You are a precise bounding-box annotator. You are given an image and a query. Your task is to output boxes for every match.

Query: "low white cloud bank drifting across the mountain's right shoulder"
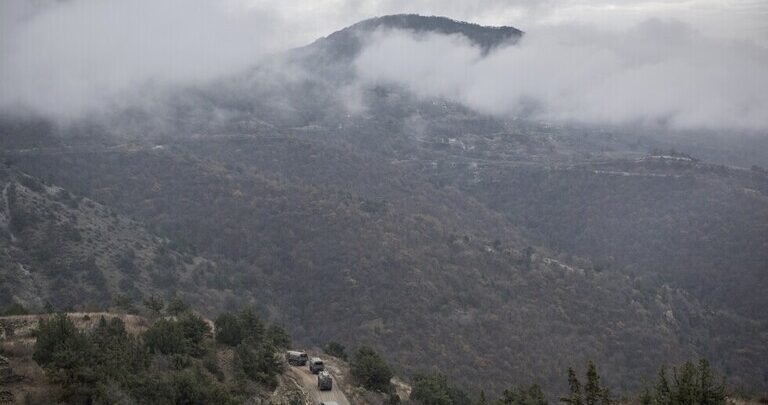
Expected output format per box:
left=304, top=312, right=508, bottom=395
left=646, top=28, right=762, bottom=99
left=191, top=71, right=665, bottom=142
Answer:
left=355, top=20, right=768, bottom=130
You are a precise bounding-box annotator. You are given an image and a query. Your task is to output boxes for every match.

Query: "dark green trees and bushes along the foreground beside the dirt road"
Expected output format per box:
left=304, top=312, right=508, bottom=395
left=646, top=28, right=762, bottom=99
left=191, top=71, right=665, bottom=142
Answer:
left=28, top=301, right=727, bottom=405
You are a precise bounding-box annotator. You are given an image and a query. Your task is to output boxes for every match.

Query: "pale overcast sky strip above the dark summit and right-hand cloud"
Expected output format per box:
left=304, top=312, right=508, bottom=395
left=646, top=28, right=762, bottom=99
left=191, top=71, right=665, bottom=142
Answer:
left=244, top=0, right=768, bottom=45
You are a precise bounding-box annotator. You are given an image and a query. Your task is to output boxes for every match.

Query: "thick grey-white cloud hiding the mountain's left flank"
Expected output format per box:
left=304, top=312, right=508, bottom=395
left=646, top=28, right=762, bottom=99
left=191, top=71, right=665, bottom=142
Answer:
left=0, top=0, right=290, bottom=119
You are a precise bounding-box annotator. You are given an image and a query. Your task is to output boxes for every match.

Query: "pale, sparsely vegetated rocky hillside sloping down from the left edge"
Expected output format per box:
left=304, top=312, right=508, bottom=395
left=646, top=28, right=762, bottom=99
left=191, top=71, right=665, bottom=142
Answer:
left=0, top=164, right=222, bottom=308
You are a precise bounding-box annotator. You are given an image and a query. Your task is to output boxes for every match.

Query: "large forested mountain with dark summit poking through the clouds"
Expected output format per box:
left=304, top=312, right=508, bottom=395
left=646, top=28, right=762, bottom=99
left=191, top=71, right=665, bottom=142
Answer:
left=0, top=16, right=768, bottom=397
